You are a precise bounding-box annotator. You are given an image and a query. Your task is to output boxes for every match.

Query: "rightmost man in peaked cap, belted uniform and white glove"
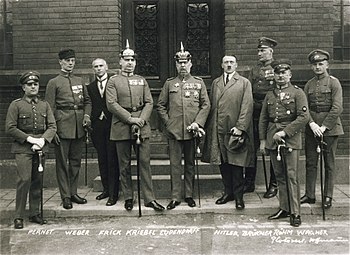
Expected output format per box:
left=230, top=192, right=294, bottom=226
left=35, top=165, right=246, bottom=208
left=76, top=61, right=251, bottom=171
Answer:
left=300, top=49, right=344, bottom=209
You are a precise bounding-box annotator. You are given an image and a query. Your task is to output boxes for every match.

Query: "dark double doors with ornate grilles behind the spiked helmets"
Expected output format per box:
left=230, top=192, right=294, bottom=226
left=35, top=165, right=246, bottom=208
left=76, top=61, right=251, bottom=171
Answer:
left=122, top=0, right=224, bottom=90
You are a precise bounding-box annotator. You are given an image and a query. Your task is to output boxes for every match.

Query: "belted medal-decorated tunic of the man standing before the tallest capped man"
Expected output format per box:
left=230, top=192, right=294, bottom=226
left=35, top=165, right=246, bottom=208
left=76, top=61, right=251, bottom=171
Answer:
left=259, top=83, right=310, bottom=150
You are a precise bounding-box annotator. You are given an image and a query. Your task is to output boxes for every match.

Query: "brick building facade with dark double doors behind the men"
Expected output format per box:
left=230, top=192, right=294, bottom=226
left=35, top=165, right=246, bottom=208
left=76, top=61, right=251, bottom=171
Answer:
left=0, top=0, right=350, bottom=185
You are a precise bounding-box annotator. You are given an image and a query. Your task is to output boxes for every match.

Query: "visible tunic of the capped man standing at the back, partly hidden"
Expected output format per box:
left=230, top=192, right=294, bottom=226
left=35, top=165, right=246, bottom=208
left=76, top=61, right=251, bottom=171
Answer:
left=248, top=59, right=276, bottom=118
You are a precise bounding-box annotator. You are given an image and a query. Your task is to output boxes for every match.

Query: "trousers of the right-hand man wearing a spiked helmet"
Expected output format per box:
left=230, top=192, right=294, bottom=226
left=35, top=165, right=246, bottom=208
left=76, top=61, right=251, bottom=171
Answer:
left=169, top=139, right=195, bottom=201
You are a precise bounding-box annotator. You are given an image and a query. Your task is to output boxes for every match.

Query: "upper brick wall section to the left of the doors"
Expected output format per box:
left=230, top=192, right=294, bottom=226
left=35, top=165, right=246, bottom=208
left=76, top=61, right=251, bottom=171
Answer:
left=13, top=0, right=121, bottom=70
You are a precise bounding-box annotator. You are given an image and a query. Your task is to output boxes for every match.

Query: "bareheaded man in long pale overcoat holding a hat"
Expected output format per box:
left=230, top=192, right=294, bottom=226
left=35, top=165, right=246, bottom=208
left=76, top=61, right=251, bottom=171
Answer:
left=202, top=56, right=254, bottom=210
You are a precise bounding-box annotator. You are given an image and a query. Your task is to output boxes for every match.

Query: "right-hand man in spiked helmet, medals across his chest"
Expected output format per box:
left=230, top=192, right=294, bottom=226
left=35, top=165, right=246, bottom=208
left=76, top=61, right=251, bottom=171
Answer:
left=157, top=43, right=210, bottom=210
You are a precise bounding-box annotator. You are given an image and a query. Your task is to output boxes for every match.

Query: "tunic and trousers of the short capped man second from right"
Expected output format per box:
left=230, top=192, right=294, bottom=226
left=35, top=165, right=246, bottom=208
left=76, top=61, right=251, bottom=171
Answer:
left=259, top=83, right=309, bottom=215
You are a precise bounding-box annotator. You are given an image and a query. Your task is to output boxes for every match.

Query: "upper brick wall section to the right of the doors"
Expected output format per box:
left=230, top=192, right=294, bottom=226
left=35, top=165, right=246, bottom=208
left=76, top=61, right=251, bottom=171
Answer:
left=225, top=0, right=333, bottom=65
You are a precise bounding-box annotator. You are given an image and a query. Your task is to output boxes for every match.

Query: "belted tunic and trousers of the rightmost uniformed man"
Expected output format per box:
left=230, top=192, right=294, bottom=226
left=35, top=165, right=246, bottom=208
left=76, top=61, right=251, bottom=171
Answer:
left=304, top=74, right=344, bottom=198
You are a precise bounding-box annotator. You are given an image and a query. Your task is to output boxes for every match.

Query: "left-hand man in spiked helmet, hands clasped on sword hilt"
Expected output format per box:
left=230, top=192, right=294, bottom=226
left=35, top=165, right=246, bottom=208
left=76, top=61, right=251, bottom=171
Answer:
left=106, top=39, right=165, bottom=211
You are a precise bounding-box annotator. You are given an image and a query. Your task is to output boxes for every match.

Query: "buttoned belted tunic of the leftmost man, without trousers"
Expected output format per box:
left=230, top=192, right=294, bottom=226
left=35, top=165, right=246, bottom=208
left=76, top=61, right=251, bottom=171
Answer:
left=6, top=96, right=56, bottom=154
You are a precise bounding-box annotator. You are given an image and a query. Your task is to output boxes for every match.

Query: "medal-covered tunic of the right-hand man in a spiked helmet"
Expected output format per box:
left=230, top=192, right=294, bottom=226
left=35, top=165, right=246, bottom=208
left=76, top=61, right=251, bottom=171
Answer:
left=157, top=74, right=210, bottom=140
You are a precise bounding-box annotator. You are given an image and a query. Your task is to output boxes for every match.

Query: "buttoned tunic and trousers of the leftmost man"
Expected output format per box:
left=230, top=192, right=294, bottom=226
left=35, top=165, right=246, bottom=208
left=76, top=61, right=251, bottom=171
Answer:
left=6, top=96, right=56, bottom=219
